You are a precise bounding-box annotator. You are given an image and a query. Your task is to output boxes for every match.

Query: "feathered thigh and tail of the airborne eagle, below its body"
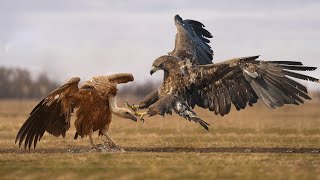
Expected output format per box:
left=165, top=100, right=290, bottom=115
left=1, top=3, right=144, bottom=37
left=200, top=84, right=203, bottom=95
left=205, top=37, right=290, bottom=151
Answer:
left=148, top=94, right=210, bottom=130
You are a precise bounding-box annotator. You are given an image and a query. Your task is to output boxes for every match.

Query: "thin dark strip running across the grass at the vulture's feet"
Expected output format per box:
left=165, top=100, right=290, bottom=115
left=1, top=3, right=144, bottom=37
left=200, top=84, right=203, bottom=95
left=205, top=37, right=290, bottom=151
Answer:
left=0, top=147, right=320, bottom=154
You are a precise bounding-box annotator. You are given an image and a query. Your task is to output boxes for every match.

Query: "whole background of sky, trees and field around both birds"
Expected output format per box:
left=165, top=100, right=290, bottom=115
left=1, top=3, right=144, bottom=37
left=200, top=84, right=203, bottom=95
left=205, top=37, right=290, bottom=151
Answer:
left=0, top=0, right=320, bottom=180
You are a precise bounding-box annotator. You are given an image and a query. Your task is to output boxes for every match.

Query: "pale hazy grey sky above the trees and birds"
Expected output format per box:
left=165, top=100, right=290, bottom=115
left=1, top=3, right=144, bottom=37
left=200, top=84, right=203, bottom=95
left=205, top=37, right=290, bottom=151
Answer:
left=0, top=0, right=320, bottom=88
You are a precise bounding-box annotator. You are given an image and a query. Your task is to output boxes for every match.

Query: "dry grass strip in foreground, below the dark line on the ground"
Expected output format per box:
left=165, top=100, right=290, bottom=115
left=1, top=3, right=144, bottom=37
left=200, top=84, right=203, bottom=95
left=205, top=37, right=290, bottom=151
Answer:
left=0, top=153, right=320, bottom=179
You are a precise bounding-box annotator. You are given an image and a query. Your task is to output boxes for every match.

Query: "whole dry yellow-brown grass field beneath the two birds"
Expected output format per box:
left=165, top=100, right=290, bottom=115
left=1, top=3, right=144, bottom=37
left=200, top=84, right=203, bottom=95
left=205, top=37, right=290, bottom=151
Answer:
left=0, top=100, right=320, bottom=179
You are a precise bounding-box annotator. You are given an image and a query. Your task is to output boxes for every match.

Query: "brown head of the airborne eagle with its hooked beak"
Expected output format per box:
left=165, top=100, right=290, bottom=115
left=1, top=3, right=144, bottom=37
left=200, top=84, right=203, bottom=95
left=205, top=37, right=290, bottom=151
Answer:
left=150, top=55, right=179, bottom=75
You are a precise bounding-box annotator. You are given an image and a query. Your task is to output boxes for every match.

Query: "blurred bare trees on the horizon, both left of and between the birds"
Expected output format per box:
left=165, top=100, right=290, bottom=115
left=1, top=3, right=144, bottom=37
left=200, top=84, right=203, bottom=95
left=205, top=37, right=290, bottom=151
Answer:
left=0, top=67, right=159, bottom=99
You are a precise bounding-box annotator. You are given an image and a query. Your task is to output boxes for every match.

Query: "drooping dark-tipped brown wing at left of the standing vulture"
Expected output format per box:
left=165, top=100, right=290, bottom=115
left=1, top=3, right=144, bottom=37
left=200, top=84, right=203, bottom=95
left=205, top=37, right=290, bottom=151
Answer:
left=16, top=77, right=80, bottom=149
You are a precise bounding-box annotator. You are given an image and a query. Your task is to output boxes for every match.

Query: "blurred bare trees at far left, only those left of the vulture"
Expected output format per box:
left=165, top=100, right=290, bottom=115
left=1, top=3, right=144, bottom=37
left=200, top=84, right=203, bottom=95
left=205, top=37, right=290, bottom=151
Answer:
left=0, top=67, right=59, bottom=99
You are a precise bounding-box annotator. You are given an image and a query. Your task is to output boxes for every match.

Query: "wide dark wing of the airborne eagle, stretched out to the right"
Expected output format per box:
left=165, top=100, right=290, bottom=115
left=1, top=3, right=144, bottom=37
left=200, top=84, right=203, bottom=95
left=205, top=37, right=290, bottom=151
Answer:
left=188, top=56, right=319, bottom=116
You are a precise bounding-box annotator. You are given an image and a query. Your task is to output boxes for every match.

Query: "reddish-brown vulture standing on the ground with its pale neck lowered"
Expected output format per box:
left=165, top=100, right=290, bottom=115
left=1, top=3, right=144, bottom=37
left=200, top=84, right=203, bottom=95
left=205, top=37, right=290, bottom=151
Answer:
left=15, top=73, right=137, bottom=151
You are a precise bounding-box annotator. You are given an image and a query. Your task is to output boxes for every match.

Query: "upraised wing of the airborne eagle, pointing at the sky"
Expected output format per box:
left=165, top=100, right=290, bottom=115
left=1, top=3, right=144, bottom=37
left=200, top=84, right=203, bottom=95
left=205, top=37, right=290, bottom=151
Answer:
left=169, top=15, right=213, bottom=64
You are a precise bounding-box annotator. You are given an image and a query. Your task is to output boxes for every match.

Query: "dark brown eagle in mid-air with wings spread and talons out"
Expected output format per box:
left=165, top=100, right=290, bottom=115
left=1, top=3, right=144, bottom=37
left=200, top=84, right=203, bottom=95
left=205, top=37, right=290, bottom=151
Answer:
left=127, top=15, right=319, bottom=130
